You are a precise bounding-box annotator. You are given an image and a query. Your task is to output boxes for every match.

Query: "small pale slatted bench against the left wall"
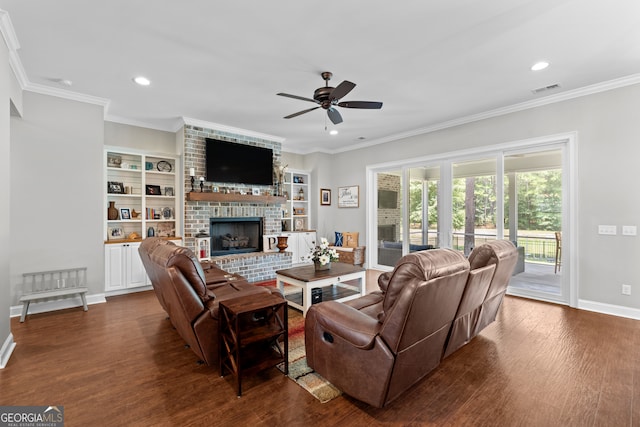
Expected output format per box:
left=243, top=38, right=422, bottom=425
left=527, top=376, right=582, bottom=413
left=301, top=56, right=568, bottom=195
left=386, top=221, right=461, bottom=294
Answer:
left=20, top=267, right=89, bottom=323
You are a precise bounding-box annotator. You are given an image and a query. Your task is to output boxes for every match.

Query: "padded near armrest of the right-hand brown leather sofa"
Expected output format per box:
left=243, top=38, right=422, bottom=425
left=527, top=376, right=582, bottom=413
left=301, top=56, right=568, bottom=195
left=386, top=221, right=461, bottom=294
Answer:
left=307, top=301, right=380, bottom=349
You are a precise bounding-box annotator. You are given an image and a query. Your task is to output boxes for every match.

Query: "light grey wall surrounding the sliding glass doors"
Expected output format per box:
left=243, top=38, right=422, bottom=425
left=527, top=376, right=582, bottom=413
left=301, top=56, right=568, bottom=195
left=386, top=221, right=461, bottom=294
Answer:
left=317, top=85, right=640, bottom=309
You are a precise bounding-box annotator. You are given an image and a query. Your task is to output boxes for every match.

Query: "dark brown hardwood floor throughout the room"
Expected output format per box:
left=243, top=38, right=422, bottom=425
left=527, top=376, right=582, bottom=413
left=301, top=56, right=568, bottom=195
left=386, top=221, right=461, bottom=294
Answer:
left=0, top=282, right=640, bottom=426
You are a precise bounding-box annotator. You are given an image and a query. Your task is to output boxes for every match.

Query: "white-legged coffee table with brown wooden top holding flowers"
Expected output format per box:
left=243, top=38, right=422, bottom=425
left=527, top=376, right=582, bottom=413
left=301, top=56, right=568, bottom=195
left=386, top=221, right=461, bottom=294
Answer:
left=276, top=262, right=366, bottom=316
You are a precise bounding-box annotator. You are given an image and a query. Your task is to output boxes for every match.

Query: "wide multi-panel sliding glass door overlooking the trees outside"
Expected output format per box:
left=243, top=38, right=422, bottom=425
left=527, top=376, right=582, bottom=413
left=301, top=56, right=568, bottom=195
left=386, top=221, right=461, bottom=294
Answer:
left=367, top=135, right=570, bottom=302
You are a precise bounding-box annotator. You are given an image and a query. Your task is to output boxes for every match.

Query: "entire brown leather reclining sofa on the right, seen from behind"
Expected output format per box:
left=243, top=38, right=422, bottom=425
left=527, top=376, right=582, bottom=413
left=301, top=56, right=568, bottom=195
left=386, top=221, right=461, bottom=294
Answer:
left=305, top=241, right=518, bottom=407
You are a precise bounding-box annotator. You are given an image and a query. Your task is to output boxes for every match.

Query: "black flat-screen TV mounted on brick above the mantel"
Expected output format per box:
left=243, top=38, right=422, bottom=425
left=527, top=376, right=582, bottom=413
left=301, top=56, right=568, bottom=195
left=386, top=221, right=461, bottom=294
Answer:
left=205, top=138, right=273, bottom=185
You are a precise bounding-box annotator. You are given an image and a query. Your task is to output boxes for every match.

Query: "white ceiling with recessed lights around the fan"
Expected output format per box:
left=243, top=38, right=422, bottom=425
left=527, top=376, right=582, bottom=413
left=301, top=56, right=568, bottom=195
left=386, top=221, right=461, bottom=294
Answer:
left=0, top=0, right=640, bottom=153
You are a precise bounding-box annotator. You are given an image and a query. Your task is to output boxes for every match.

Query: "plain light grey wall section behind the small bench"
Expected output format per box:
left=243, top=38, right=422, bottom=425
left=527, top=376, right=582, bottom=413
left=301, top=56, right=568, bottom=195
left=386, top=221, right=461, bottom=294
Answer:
left=9, top=92, right=104, bottom=305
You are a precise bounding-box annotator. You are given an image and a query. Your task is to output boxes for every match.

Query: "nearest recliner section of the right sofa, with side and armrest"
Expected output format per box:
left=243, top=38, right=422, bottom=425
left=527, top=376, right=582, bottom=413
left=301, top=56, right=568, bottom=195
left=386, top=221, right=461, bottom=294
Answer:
left=305, top=249, right=469, bottom=407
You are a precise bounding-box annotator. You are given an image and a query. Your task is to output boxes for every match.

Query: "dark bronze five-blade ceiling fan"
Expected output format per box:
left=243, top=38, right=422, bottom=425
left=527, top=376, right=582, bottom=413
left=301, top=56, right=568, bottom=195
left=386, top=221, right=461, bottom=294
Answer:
left=278, top=71, right=382, bottom=125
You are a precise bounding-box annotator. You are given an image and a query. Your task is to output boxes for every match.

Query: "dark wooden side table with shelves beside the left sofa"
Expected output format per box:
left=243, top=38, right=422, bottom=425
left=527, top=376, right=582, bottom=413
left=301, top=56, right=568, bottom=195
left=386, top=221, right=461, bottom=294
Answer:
left=218, top=293, right=289, bottom=397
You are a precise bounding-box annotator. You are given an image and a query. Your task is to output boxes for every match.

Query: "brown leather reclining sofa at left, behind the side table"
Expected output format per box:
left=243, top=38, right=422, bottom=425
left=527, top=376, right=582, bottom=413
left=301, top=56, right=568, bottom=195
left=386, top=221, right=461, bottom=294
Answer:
left=139, top=237, right=281, bottom=366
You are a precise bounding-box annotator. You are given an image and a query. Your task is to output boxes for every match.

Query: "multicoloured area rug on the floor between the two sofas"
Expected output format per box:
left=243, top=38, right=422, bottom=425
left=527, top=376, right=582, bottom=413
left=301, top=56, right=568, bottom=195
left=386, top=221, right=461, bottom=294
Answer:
left=254, top=280, right=342, bottom=403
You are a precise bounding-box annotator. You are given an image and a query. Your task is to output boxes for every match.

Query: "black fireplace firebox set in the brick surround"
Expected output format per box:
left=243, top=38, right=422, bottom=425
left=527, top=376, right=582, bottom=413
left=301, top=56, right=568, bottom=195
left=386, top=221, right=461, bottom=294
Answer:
left=209, top=217, right=263, bottom=256
